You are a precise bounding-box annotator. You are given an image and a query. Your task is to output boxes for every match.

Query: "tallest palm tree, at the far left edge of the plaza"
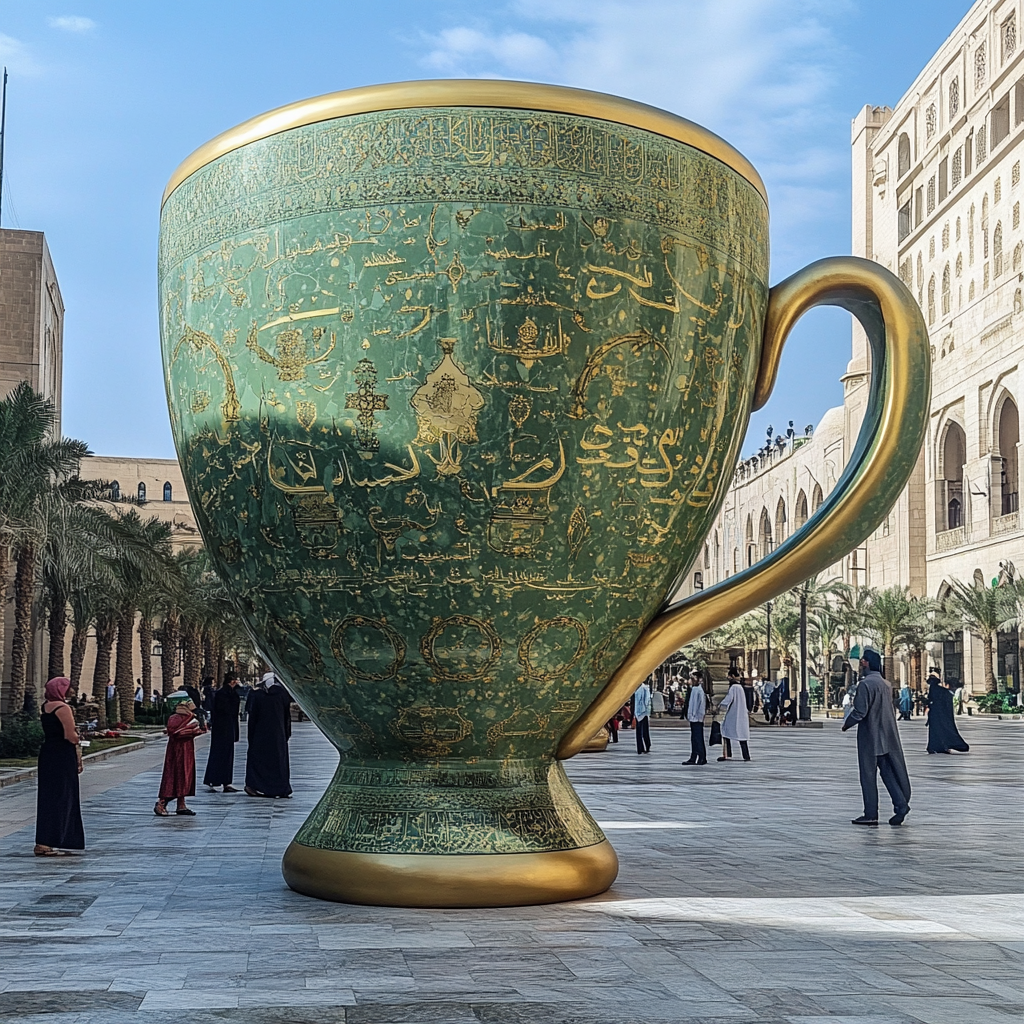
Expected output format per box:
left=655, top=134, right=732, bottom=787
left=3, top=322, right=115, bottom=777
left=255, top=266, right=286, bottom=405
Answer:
left=0, top=381, right=89, bottom=710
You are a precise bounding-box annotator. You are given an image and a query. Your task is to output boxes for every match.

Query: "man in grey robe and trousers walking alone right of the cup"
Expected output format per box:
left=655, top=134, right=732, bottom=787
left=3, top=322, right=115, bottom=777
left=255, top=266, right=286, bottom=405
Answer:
left=843, top=647, right=910, bottom=825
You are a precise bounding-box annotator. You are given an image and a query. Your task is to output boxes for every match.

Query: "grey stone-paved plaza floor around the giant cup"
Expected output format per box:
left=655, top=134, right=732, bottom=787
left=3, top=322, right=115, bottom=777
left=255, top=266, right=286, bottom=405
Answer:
left=0, top=718, right=1024, bottom=1024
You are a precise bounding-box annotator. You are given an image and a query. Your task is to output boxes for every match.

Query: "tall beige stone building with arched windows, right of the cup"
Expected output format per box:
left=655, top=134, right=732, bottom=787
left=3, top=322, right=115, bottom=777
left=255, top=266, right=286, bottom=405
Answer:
left=689, top=0, right=1024, bottom=689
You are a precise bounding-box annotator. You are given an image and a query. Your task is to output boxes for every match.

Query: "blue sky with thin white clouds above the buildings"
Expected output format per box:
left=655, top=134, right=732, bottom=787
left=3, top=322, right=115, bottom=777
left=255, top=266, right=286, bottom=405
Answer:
left=0, top=0, right=970, bottom=457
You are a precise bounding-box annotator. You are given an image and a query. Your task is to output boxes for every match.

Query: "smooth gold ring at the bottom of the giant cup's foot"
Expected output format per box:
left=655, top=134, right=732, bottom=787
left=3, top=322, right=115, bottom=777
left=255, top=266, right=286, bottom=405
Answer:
left=282, top=840, right=618, bottom=907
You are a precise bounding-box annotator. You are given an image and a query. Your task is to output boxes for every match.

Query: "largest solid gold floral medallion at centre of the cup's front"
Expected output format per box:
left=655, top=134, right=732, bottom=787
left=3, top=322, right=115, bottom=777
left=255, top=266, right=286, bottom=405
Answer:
left=411, top=338, right=483, bottom=476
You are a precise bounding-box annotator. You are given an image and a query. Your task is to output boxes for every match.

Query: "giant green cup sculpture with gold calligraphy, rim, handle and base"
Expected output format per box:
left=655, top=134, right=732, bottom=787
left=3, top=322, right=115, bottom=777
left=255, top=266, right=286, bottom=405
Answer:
left=159, top=81, right=929, bottom=906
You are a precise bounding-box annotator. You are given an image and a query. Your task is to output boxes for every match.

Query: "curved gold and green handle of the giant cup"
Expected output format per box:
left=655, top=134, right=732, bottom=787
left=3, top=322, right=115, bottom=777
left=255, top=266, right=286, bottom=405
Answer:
left=557, top=256, right=931, bottom=759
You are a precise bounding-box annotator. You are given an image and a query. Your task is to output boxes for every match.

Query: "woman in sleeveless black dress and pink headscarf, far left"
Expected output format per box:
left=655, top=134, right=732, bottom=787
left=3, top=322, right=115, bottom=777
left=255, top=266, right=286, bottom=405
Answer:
left=35, top=676, right=85, bottom=857
